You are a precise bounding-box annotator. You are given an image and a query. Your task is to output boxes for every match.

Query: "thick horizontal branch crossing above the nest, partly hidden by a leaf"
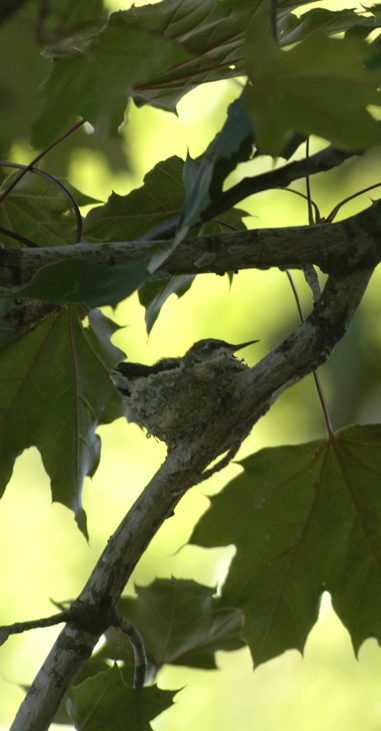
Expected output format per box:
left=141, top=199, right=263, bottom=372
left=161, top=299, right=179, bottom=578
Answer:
left=0, top=201, right=381, bottom=288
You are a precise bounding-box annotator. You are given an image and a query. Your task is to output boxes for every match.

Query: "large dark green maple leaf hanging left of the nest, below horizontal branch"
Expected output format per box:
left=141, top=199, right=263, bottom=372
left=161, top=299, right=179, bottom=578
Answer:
left=0, top=308, right=124, bottom=535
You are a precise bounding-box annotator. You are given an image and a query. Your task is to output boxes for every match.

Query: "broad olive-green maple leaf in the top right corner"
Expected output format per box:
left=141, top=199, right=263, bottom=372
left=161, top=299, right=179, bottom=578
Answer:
left=246, top=6, right=381, bottom=157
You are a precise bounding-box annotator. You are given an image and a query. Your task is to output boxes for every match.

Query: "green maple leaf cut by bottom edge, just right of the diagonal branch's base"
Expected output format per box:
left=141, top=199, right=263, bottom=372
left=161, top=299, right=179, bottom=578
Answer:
left=67, top=665, right=177, bottom=731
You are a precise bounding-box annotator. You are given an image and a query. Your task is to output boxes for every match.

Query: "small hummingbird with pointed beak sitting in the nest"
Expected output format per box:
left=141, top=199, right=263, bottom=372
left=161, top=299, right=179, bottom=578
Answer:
left=111, top=338, right=259, bottom=396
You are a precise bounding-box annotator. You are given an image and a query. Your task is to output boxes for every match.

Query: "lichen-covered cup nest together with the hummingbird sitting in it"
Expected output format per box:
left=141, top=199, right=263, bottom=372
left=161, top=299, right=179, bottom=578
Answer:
left=111, top=338, right=258, bottom=449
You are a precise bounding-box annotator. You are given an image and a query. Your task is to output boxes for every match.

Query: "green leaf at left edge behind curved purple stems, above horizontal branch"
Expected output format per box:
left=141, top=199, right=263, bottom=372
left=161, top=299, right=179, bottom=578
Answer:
left=0, top=171, right=97, bottom=247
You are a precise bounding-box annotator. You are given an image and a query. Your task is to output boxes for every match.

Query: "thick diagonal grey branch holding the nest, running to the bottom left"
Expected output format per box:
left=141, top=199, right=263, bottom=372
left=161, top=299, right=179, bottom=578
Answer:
left=11, top=260, right=372, bottom=731
